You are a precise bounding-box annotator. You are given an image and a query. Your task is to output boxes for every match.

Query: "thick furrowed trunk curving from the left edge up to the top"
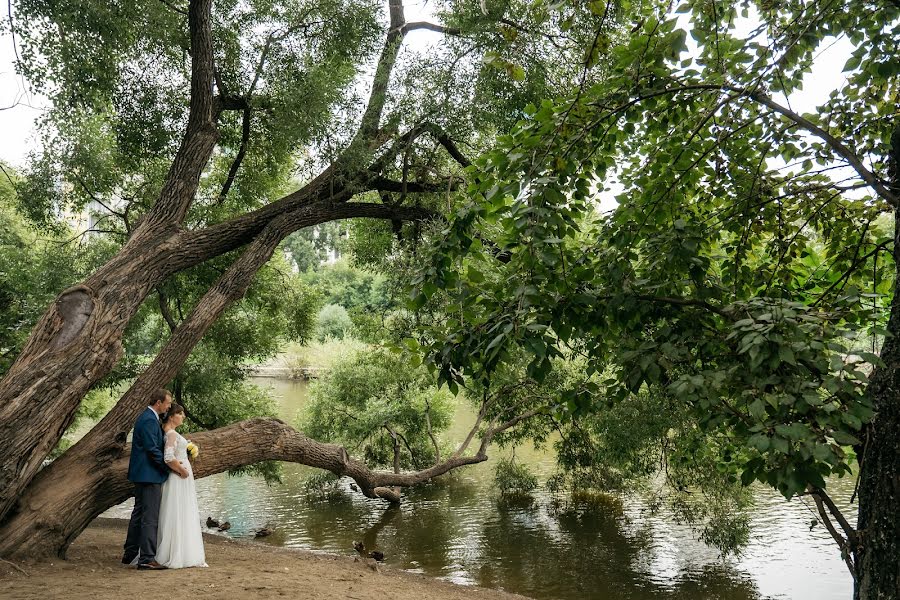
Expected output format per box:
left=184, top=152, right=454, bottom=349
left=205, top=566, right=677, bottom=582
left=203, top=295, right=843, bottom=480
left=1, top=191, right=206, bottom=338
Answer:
left=0, top=0, right=217, bottom=521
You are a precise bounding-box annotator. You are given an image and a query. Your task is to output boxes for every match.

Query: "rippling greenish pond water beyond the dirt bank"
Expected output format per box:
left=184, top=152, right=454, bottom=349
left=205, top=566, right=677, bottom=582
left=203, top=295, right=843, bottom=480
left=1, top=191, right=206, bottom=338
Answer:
left=105, top=378, right=855, bottom=600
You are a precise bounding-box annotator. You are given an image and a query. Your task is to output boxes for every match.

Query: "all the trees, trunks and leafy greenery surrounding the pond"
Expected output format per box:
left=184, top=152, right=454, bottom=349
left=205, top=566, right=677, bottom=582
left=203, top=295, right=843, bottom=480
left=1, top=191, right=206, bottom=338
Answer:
left=0, top=0, right=900, bottom=599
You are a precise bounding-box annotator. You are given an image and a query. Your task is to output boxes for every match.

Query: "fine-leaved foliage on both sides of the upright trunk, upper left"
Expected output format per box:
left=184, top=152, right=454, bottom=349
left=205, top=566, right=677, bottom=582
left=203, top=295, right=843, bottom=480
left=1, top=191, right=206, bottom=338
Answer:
left=10, top=0, right=380, bottom=227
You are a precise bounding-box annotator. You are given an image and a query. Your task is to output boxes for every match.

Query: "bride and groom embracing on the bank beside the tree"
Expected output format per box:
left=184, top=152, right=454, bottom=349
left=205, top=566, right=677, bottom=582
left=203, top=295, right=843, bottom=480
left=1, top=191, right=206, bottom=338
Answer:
left=122, top=389, right=206, bottom=570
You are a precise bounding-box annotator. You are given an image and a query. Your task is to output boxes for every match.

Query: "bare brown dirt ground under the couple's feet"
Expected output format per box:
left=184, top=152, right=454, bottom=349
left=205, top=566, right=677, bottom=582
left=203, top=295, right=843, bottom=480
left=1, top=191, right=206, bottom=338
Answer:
left=0, top=519, right=527, bottom=600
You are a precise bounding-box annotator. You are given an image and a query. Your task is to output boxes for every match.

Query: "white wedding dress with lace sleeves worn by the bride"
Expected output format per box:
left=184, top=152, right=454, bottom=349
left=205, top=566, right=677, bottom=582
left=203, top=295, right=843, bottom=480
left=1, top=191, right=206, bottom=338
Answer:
left=156, top=429, right=207, bottom=569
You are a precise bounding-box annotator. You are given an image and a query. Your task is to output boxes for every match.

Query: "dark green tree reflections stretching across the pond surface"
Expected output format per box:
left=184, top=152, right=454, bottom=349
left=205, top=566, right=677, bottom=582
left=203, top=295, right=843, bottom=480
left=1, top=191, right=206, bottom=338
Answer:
left=214, top=466, right=759, bottom=600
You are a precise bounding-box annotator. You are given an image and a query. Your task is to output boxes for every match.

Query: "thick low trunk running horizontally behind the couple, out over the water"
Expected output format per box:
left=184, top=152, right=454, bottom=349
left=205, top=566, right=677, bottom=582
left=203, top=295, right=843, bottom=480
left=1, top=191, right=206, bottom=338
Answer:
left=0, top=419, right=487, bottom=558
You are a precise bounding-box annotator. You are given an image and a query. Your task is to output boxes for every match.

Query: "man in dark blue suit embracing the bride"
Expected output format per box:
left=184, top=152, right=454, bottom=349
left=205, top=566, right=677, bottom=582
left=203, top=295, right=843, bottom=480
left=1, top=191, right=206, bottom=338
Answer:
left=122, top=389, right=172, bottom=570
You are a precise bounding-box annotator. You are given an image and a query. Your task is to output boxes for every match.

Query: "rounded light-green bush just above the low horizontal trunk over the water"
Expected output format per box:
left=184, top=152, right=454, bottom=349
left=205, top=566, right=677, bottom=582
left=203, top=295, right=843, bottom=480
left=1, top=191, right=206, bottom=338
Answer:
left=300, top=348, right=453, bottom=469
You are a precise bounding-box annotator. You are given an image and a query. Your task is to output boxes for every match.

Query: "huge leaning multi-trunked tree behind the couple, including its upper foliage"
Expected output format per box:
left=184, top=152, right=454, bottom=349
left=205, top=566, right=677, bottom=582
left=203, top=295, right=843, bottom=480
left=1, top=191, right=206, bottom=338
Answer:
left=0, top=0, right=612, bottom=557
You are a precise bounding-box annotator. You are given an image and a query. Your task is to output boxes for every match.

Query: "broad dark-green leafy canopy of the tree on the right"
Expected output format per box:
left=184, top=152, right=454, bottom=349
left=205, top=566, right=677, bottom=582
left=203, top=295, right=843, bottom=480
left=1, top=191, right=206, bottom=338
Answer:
left=413, top=2, right=900, bottom=516
